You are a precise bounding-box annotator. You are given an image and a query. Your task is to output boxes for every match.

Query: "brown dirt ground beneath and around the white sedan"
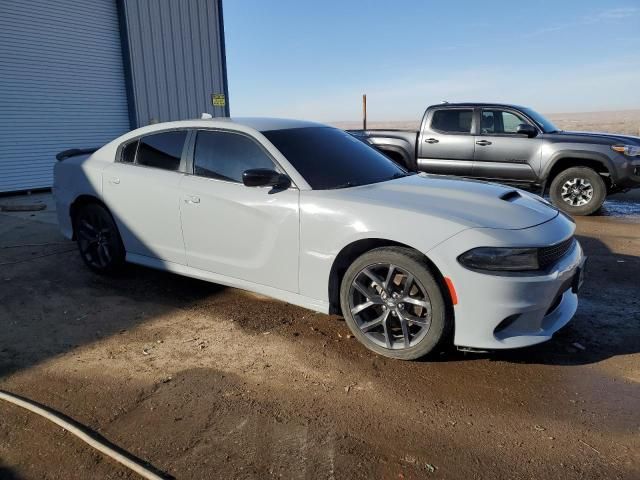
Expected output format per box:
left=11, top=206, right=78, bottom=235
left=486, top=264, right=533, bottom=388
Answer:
left=0, top=192, right=640, bottom=479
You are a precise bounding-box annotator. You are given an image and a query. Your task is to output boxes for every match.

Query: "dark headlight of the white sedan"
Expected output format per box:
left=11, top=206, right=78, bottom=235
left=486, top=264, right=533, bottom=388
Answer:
left=458, top=247, right=540, bottom=272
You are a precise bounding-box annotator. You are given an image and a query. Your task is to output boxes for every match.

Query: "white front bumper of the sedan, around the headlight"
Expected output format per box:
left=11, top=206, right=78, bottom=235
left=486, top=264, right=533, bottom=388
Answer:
left=429, top=216, right=585, bottom=349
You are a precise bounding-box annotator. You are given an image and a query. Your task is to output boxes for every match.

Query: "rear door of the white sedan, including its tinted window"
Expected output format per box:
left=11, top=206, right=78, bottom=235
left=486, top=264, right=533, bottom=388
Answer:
left=102, top=130, right=188, bottom=265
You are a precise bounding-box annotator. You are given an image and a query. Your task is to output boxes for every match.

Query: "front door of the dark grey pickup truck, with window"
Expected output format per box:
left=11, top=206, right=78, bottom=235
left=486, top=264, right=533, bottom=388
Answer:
left=473, top=107, right=542, bottom=182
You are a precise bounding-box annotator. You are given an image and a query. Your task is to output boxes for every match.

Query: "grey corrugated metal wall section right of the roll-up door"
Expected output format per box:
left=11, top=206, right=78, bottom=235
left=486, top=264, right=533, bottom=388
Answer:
left=120, top=0, right=229, bottom=126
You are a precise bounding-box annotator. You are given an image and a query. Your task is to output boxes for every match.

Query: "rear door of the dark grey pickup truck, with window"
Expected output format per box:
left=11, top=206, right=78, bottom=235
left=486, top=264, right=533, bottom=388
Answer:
left=418, top=107, right=475, bottom=176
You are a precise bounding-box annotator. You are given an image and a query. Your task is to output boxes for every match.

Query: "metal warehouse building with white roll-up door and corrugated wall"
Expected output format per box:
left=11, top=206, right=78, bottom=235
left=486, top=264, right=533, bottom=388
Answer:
left=0, top=0, right=229, bottom=192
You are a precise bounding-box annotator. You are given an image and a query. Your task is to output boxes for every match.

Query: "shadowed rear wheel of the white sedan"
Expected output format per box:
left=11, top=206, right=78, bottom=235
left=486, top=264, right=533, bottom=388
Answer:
left=74, top=203, right=125, bottom=274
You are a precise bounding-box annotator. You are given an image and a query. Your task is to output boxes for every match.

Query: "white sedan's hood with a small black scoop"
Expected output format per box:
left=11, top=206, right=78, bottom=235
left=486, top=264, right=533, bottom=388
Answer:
left=342, top=173, right=558, bottom=230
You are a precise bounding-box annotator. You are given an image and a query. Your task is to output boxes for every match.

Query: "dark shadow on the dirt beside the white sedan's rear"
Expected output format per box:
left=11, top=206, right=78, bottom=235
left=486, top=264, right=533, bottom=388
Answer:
left=0, top=210, right=225, bottom=380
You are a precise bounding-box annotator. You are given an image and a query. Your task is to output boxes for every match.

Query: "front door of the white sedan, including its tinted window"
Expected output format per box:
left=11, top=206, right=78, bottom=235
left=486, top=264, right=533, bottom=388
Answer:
left=181, top=130, right=299, bottom=292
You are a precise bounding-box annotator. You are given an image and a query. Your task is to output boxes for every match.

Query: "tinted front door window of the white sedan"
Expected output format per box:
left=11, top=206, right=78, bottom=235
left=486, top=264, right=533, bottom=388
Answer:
left=194, top=132, right=275, bottom=182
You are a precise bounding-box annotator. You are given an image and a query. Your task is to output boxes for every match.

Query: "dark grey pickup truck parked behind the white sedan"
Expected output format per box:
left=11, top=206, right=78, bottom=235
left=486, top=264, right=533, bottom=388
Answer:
left=349, top=103, right=640, bottom=215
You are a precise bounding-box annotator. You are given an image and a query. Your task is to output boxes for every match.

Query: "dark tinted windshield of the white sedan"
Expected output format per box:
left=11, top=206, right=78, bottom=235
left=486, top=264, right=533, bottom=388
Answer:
left=262, top=127, right=408, bottom=190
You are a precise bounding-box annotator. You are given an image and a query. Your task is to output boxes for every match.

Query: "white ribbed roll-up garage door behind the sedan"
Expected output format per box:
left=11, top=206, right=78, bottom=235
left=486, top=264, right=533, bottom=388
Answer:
left=0, top=0, right=129, bottom=192
